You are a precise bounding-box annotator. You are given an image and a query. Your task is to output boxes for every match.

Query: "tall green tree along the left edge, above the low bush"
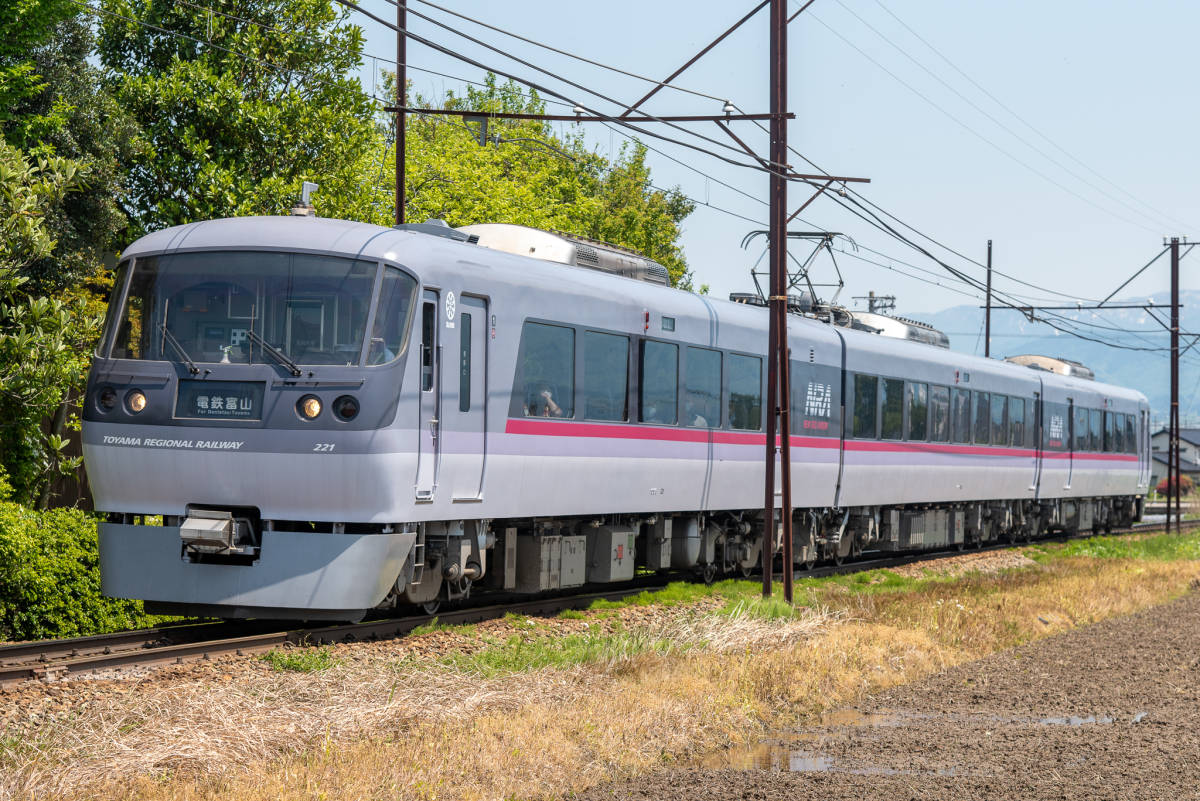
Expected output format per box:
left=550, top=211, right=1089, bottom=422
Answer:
left=0, top=7, right=133, bottom=507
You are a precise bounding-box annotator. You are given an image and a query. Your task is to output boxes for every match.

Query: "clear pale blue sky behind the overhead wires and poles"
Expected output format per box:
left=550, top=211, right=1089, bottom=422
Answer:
left=348, top=0, right=1200, bottom=313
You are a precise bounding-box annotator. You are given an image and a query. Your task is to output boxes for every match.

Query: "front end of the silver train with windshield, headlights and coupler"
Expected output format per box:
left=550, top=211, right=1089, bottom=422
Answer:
left=83, top=237, right=441, bottom=619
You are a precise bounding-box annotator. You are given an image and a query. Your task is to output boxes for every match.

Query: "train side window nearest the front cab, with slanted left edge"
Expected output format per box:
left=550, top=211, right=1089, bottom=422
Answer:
left=510, top=323, right=575, bottom=417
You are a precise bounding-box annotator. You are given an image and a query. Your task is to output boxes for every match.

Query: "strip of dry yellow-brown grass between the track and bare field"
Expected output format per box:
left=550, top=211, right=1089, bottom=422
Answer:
left=9, top=558, right=1200, bottom=800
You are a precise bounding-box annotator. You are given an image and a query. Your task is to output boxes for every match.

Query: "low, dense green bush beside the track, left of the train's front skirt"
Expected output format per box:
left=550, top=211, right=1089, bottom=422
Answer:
left=0, top=501, right=155, bottom=639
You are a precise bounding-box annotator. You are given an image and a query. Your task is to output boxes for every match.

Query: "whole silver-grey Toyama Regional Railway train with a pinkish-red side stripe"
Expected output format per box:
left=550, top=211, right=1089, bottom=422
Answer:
left=83, top=216, right=1150, bottom=620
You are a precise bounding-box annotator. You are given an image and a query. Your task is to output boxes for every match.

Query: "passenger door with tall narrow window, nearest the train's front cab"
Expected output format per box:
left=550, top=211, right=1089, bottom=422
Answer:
left=442, top=293, right=490, bottom=501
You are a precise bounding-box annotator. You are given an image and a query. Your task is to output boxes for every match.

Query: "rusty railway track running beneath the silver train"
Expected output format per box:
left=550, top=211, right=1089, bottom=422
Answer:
left=0, top=520, right=1200, bottom=688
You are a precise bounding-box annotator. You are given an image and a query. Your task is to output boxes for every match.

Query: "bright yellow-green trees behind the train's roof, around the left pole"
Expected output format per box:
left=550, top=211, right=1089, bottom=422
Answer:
left=350, top=76, right=695, bottom=289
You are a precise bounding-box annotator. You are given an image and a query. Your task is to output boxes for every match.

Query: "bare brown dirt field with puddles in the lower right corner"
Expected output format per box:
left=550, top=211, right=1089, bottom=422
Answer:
left=581, top=592, right=1200, bottom=801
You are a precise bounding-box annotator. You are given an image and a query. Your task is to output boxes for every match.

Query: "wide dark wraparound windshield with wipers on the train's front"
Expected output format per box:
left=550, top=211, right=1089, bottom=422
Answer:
left=110, top=252, right=415, bottom=366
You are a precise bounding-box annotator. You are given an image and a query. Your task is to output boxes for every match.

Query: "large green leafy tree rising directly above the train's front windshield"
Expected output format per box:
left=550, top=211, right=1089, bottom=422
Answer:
left=98, top=0, right=377, bottom=231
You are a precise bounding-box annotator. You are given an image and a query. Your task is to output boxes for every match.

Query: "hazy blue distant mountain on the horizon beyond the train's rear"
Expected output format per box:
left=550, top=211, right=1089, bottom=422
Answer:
left=899, top=291, right=1200, bottom=424
